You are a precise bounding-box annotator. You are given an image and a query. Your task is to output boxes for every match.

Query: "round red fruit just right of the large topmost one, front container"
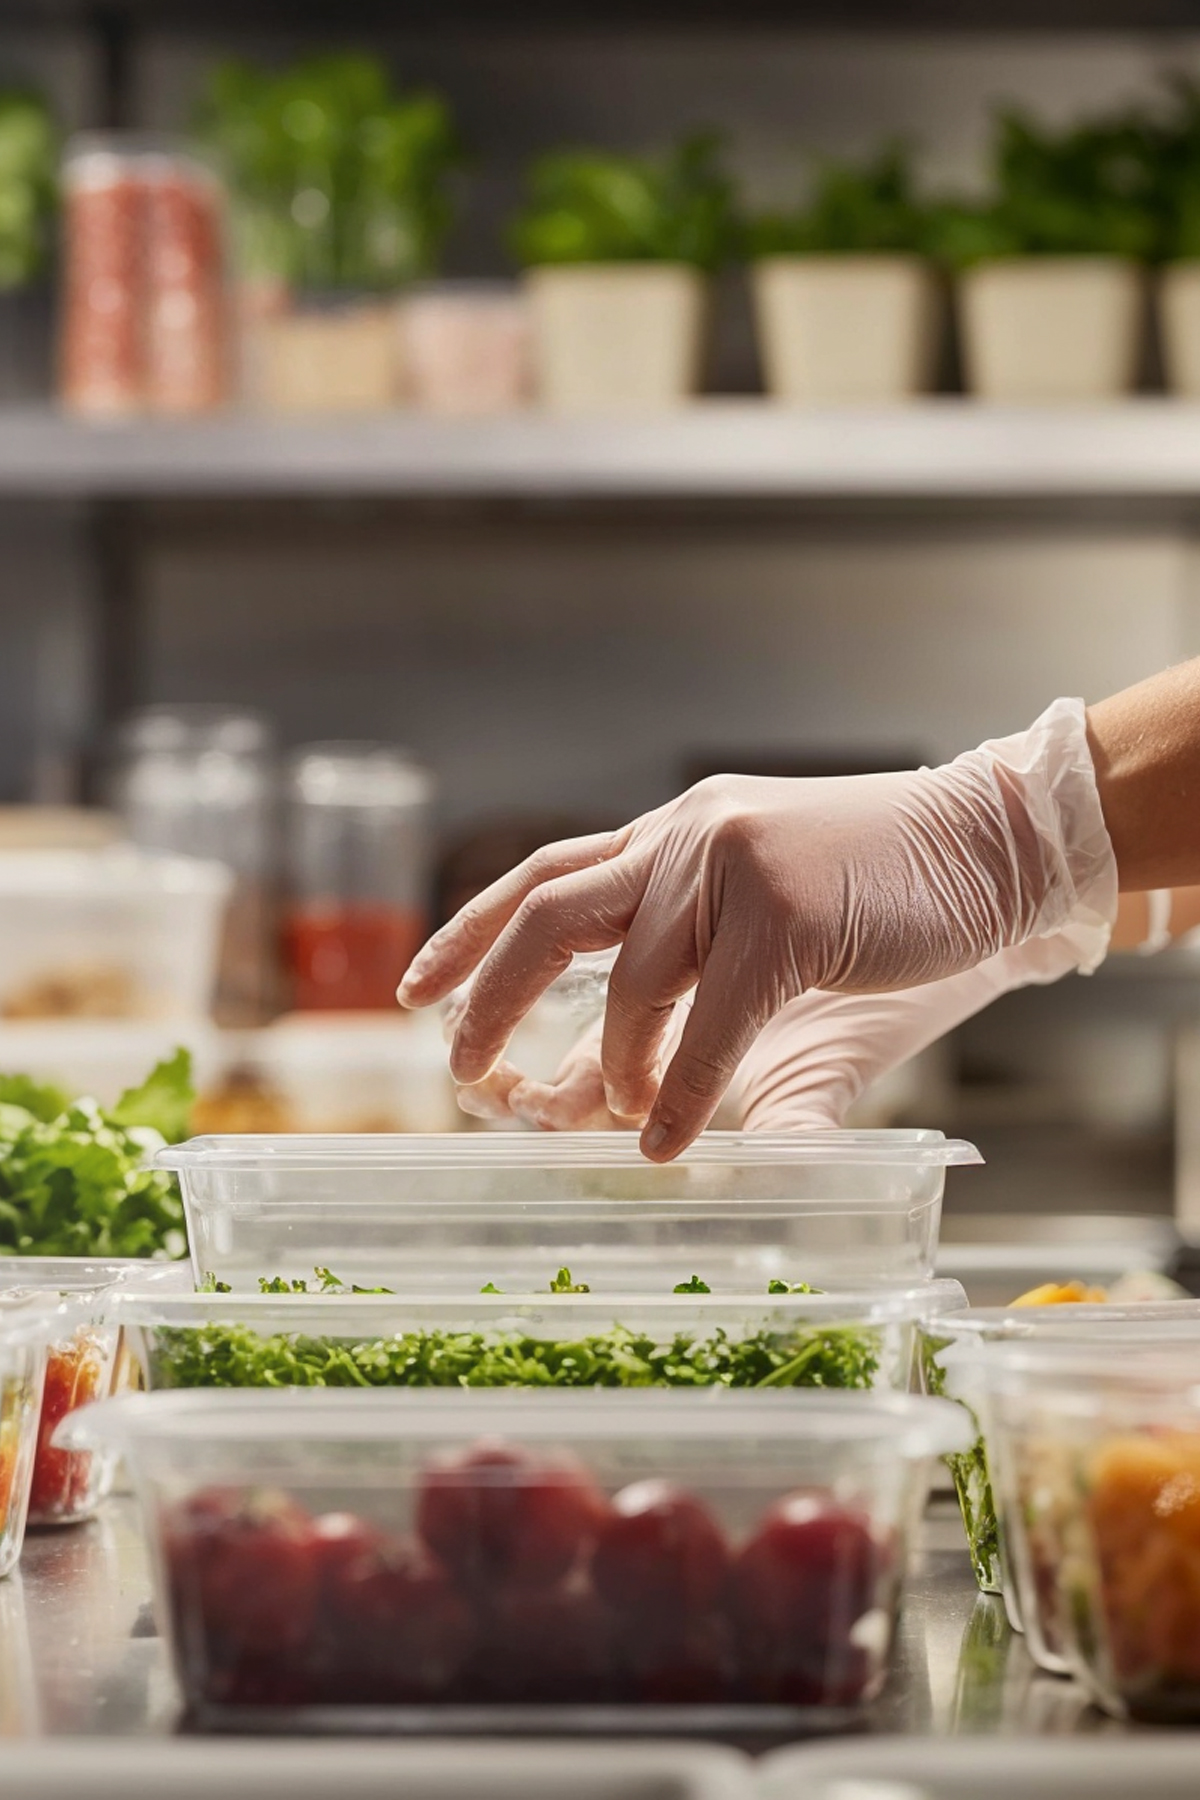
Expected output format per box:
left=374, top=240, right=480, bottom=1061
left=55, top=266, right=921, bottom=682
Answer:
left=592, top=1481, right=730, bottom=1631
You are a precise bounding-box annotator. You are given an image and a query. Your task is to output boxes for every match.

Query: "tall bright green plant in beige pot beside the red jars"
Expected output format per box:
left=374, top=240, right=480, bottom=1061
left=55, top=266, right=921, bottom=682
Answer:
left=201, top=56, right=457, bottom=410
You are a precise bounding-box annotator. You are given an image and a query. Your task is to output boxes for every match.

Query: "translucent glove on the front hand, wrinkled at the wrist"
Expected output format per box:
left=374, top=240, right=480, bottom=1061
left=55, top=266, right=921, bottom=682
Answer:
left=399, top=700, right=1117, bottom=1161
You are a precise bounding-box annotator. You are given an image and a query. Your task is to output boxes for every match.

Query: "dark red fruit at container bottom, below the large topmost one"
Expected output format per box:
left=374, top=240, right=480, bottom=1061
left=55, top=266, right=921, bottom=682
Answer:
left=466, top=1575, right=615, bottom=1706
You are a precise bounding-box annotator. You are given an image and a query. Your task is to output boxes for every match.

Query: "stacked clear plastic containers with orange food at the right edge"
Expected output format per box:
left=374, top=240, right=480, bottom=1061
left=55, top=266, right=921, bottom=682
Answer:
left=923, top=1300, right=1200, bottom=1721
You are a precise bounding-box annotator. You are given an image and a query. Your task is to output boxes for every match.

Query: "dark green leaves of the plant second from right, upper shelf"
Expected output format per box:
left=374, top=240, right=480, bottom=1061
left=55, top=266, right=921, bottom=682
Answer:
left=928, top=112, right=1162, bottom=268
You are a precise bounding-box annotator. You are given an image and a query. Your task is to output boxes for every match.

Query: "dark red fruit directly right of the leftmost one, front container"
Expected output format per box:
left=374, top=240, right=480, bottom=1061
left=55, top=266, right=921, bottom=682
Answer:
left=318, top=1516, right=475, bottom=1703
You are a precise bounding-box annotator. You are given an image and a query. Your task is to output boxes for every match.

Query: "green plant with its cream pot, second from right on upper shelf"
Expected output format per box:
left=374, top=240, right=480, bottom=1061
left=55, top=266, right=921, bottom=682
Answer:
left=934, top=113, right=1159, bottom=403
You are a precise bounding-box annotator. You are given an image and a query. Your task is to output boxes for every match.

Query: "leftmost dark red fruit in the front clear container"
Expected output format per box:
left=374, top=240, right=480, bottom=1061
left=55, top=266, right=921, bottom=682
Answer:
left=164, top=1489, right=318, bottom=1661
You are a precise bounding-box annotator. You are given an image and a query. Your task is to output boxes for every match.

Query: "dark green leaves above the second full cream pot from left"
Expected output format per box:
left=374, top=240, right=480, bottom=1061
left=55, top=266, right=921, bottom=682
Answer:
left=747, top=144, right=930, bottom=257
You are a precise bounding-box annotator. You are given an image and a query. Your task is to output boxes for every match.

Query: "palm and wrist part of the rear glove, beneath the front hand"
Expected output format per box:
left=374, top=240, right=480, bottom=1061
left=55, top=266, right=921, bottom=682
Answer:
left=727, top=934, right=1079, bottom=1130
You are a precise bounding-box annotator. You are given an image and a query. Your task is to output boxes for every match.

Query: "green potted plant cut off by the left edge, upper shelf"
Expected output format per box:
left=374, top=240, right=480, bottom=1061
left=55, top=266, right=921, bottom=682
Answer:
left=0, top=90, right=58, bottom=401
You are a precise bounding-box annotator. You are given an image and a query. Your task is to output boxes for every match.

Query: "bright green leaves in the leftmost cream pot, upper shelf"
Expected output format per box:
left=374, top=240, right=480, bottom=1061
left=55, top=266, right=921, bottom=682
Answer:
left=511, top=133, right=736, bottom=270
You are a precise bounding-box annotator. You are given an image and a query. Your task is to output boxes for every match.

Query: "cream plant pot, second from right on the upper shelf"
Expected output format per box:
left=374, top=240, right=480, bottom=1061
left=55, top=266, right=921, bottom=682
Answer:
left=959, top=256, right=1146, bottom=405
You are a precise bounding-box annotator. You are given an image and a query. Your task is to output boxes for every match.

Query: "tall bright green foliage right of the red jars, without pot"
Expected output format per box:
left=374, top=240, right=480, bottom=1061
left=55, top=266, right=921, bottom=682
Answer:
left=198, top=56, right=461, bottom=290
